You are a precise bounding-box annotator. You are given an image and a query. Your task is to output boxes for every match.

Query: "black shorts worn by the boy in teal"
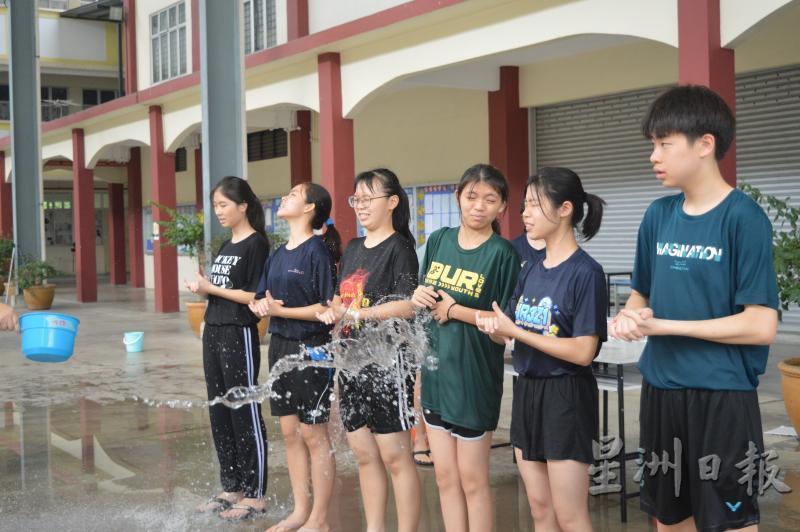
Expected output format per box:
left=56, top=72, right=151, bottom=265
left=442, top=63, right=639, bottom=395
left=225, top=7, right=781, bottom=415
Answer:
left=636, top=382, right=764, bottom=531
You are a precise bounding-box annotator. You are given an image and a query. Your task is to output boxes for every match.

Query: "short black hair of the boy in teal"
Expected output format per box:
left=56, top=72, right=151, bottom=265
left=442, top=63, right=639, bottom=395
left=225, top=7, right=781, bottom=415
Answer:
left=642, top=85, right=736, bottom=161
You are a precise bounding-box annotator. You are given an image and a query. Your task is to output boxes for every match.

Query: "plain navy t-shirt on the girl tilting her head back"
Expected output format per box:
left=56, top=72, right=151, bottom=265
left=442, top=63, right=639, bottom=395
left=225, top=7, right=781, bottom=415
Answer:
left=256, top=236, right=336, bottom=341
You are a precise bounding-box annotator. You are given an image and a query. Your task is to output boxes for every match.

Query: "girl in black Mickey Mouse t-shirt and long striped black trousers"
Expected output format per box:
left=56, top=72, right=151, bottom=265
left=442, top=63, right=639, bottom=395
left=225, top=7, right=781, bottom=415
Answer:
left=186, top=176, right=269, bottom=520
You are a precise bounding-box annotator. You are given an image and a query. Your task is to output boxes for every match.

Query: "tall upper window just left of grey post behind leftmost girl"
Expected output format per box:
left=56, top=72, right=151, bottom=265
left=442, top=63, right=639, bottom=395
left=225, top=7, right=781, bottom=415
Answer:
left=150, top=2, right=187, bottom=83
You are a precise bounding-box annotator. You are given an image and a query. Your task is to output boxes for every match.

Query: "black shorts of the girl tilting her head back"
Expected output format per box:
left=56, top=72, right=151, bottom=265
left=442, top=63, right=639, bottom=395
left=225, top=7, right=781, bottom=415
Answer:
left=269, top=334, right=335, bottom=425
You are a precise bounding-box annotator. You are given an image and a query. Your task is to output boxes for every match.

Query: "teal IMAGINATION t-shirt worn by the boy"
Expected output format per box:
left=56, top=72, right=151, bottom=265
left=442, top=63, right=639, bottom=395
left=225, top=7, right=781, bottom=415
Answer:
left=632, top=189, right=778, bottom=390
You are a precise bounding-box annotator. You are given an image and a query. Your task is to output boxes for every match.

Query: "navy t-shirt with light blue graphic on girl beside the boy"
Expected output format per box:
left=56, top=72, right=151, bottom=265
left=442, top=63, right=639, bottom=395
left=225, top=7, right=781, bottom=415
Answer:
left=506, top=248, right=608, bottom=378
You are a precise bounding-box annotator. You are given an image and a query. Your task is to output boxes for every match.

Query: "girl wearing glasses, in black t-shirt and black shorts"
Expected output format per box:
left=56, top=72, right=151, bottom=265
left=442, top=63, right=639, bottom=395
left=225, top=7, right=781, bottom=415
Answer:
left=319, top=168, right=420, bottom=532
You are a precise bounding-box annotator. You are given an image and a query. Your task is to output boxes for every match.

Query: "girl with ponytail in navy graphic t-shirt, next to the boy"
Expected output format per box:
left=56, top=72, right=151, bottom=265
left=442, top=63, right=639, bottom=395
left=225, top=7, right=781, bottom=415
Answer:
left=477, top=168, right=608, bottom=530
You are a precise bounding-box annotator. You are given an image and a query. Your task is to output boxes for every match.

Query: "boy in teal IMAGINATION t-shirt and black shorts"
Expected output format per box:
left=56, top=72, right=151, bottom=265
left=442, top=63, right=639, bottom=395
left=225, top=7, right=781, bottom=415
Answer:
left=609, top=86, right=778, bottom=531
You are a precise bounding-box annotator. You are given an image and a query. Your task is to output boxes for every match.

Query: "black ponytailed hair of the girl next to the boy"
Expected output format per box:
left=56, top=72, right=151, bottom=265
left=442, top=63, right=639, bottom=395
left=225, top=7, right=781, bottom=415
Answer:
left=527, top=167, right=606, bottom=241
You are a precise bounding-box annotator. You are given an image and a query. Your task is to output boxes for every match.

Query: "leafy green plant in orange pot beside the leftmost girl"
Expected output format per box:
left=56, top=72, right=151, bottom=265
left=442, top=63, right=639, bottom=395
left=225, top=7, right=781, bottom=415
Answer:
left=151, top=202, right=207, bottom=338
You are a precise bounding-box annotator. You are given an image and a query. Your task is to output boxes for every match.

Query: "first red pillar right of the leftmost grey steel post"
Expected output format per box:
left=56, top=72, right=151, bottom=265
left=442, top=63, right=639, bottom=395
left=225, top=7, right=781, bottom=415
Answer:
left=72, top=129, right=97, bottom=303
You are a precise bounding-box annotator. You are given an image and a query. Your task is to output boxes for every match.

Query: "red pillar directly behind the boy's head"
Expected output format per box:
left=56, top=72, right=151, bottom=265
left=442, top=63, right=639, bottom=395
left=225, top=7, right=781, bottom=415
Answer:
left=678, top=0, right=736, bottom=186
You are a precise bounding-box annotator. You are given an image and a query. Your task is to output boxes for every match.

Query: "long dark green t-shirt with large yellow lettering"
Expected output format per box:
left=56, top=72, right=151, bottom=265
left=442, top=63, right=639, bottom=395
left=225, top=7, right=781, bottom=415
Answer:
left=420, top=227, right=520, bottom=431
